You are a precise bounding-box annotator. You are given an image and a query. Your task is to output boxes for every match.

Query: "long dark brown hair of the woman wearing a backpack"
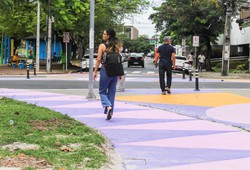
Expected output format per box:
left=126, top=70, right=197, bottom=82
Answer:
left=106, top=28, right=121, bottom=52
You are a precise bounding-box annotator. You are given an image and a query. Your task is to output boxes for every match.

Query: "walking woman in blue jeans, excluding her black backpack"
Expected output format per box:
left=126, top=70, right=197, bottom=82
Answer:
left=93, top=29, right=122, bottom=120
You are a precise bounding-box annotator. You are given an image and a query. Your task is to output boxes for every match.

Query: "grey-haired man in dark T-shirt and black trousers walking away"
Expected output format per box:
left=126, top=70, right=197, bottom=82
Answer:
left=154, top=36, right=176, bottom=95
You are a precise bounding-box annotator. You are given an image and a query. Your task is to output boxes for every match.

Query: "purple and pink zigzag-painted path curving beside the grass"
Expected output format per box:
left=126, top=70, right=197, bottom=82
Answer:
left=0, top=89, right=250, bottom=170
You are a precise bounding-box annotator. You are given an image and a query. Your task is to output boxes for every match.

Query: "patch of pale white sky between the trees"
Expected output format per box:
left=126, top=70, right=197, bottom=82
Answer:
left=124, top=0, right=163, bottom=38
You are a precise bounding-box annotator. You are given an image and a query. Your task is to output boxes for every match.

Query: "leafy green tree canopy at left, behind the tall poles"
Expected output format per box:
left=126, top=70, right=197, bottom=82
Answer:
left=0, top=0, right=148, bottom=61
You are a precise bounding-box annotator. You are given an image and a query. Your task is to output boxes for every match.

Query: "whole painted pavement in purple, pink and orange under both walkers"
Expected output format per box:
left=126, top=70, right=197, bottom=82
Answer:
left=0, top=85, right=250, bottom=170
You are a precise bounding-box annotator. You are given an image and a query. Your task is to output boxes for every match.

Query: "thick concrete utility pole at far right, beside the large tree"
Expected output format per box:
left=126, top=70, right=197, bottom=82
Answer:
left=221, top=0, right=233, bottom=76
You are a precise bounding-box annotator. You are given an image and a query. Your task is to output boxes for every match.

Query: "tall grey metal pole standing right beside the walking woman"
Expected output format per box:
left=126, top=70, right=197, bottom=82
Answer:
left=86, top=0, right=96, bottom=99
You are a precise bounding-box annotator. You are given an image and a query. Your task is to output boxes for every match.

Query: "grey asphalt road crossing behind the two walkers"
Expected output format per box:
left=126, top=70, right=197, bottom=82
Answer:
left=0, top=59, right=250, bottom=89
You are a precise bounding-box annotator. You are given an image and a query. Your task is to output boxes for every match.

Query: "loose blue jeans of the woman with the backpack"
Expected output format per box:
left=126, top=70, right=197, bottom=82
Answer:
left=99, top=67, right=118, bottom=111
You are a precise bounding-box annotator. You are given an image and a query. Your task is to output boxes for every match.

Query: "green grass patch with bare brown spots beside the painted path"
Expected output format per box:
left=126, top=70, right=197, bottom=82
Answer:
left=0, top=98, right=107, bottom=170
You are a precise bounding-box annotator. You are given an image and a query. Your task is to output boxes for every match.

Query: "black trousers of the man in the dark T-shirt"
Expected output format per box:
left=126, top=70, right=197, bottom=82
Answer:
left=159, top=63, right=172, bottom=91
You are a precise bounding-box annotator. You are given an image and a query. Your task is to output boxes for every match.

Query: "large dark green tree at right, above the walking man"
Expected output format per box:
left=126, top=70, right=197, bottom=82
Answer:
left=150, top=0, right=227, bottom=70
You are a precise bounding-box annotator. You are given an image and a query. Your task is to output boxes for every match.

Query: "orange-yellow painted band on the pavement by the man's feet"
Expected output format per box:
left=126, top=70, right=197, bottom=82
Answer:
left=116, top=92, right=250, bottom=107
